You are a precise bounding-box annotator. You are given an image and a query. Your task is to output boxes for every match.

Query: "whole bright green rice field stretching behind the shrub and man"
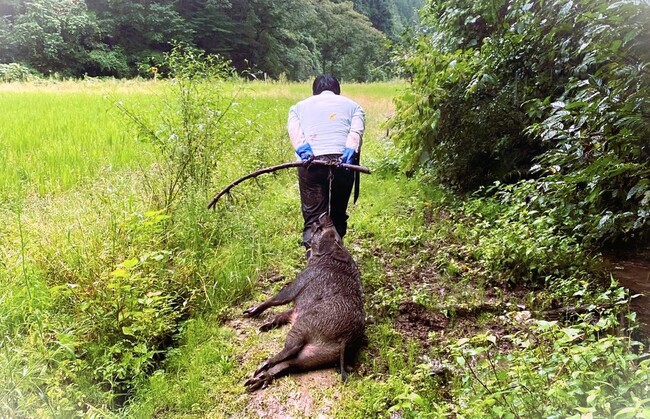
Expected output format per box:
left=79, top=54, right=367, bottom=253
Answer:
left=0, top=81, right=396, bottom=196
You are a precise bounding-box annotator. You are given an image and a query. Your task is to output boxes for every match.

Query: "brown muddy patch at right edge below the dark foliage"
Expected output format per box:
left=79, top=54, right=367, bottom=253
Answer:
left=607, top=249, right=650, bottom=339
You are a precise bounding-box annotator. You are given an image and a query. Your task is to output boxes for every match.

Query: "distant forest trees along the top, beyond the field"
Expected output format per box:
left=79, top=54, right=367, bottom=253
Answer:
left=0, top=0, right=421, bottom=80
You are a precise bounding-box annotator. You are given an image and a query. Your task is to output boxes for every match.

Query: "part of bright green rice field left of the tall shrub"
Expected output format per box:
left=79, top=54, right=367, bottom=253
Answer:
left=0, top=84, right=157, bottom=194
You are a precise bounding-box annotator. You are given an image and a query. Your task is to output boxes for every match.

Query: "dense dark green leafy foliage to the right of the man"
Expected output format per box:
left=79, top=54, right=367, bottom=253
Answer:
left=393, top=0, right=650, bottom=243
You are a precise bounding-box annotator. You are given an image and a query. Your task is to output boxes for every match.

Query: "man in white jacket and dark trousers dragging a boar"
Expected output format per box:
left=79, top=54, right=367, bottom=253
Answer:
left=287, top=74, right=365, bottom=257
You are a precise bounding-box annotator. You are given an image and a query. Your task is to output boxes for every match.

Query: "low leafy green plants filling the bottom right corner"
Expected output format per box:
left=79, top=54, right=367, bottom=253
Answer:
left=448, top=312, right=650, bottom=418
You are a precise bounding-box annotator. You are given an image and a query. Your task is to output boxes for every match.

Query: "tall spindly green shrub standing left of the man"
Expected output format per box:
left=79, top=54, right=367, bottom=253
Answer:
left=116, top=44, right=239, bottom=208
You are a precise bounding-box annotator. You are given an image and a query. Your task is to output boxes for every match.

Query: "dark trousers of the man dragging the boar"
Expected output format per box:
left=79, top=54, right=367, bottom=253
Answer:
left=298, top=154, right=354, bottom=248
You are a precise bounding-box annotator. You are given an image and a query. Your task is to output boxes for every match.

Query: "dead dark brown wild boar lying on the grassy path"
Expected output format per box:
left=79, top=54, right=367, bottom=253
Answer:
left=244, top=214, right=365, bottom=391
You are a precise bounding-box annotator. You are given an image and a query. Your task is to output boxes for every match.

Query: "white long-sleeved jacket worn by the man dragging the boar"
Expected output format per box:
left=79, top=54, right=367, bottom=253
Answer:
left=287, top=90, right=365, bottom=156
